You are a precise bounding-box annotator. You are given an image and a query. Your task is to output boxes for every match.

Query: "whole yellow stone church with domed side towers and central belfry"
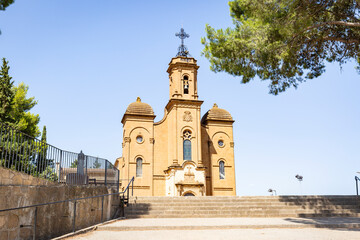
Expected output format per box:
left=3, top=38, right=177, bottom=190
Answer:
left=115, top=29, right=236, bottom=196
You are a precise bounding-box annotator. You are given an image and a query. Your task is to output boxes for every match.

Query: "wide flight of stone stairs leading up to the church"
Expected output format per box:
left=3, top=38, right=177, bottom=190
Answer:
left=125, top=196, right=360, bottom=218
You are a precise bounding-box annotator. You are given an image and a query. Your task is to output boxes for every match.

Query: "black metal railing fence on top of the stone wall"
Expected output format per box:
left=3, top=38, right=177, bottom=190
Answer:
left=0, top=122, right=120, bottom=189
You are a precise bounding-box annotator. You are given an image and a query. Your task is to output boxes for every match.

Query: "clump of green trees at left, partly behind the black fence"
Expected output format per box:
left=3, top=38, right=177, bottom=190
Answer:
left=0, top=59, right=52, bottom=179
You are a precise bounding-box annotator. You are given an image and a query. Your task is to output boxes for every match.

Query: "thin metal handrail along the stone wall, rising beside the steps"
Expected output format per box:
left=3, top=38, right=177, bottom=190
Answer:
left=0, top=177, right=135, bottom=240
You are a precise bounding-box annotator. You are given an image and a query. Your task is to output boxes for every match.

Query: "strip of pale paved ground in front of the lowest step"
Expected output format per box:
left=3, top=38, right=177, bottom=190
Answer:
left=67, top=228, right=360, bottom=240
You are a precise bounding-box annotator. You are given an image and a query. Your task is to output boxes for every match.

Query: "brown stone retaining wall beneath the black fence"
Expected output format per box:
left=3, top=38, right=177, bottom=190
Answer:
left=0, top=168, right=120, bottom=240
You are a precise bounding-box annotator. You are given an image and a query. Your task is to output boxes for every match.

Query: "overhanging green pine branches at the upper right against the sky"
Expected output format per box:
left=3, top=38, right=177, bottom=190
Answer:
left=202, top=0, right=360, bottom=95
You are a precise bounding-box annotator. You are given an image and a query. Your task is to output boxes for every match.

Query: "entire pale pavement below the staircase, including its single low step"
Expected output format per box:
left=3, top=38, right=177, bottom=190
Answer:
left=67, top=218, right=360, bottom=240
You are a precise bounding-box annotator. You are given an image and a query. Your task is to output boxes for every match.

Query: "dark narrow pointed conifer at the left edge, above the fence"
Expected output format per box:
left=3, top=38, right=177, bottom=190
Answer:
left=0, top=58, right=15, bottom=123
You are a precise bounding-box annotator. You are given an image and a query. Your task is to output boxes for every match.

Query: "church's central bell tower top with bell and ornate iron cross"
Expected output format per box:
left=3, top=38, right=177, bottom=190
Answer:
left=167, top=28, right=199, bottom=100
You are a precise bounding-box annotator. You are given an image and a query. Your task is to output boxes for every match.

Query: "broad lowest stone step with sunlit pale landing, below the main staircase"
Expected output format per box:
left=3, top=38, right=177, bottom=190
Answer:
left=97, top=217, right=360, bottom=232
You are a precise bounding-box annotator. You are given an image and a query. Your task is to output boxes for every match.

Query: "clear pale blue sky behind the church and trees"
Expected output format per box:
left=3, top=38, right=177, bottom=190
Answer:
left=0, top=0, right=360, bottom=196
